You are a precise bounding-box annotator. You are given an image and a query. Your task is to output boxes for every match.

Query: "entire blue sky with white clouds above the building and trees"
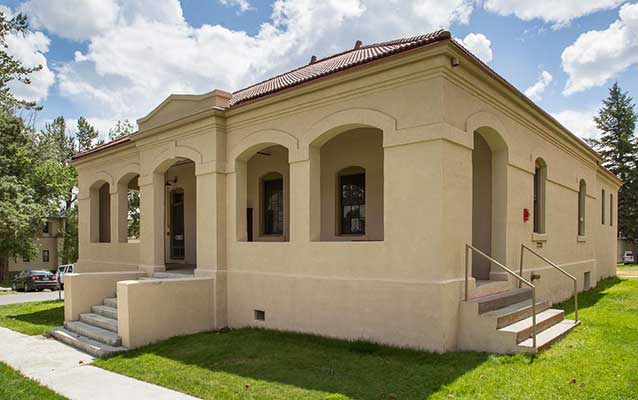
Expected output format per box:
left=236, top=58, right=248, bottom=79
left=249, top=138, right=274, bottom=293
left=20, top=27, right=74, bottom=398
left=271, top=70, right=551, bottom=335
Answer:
left=0, top=0, right=638, bottom=137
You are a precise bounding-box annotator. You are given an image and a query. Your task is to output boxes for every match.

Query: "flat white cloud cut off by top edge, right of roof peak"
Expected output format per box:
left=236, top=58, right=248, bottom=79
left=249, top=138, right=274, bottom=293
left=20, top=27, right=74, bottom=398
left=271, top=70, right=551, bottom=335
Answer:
left=483, top=0, right=625, bottom=29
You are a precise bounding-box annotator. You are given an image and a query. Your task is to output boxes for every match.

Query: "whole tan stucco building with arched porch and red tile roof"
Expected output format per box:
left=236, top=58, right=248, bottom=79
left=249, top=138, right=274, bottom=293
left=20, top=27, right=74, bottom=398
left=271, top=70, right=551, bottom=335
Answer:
left=58, top=31, right=621, bottom=352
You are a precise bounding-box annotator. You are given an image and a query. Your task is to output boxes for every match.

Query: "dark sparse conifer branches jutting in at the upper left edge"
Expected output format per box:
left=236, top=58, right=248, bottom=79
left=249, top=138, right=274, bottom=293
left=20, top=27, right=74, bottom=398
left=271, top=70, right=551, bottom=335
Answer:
left=0, top=11, right=42, bottom=113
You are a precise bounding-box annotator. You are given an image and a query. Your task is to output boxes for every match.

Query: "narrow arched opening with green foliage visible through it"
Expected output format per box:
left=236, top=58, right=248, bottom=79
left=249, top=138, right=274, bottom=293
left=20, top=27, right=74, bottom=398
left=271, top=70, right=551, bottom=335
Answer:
left=117, top=173, right=141, bottom=243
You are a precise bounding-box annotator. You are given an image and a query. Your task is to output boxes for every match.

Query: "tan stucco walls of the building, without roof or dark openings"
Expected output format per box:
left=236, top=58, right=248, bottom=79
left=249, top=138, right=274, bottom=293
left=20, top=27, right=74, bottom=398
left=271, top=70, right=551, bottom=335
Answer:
left=76, top=45, right=618, bottom=351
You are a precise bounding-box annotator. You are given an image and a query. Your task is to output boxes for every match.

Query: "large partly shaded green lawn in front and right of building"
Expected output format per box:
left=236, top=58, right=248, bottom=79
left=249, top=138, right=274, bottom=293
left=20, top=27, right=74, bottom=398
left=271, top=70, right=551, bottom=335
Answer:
left=96, top=278, right=638, bottom=400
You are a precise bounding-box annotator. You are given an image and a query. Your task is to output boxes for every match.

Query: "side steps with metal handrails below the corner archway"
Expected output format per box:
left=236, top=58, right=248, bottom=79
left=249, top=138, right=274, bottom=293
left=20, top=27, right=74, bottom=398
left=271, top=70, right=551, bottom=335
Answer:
left=458, top=288, right=578, bottom=354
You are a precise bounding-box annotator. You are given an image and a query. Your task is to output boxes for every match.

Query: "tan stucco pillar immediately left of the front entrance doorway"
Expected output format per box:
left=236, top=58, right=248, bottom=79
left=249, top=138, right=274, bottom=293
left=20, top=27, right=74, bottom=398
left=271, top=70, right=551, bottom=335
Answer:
left=139, top=173, right=166, bottom=272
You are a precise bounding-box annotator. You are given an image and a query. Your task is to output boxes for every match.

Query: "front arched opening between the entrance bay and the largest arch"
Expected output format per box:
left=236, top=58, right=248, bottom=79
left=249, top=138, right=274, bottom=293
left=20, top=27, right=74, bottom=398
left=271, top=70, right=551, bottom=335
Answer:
left=236, top=145, right=290, bottom=242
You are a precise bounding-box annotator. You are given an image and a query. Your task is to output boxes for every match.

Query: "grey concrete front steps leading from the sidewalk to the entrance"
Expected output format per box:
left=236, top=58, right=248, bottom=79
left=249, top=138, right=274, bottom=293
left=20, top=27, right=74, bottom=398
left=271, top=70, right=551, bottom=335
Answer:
left=51, top=298, right=127, bottom=358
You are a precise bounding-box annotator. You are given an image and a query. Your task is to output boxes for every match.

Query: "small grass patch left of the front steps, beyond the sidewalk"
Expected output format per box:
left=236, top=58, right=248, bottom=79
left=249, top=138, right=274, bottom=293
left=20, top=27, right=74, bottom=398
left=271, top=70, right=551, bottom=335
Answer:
left=0, top=300, right=64, bottom=334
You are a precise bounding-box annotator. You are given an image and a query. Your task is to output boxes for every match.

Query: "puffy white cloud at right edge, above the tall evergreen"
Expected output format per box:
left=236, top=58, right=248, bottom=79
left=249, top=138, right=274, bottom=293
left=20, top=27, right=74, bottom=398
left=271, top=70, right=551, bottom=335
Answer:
left=561, top=3, right=638, bottom=95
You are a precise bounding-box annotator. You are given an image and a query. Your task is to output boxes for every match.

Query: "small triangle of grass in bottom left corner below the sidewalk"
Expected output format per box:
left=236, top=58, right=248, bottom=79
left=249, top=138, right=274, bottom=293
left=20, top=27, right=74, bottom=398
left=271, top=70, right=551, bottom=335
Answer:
left=0, top=362, right=64, bottom=400
